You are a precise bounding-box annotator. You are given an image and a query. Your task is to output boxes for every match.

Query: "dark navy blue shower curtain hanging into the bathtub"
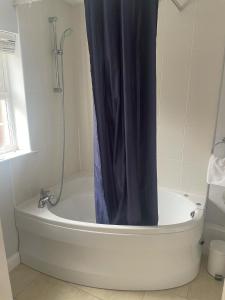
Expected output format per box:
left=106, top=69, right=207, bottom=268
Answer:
left=85, top=0, right=158, bottom=225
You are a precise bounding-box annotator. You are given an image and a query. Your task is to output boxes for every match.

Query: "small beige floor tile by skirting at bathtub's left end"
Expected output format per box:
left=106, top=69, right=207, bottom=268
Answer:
left=10, top=264, right=40, bottom=297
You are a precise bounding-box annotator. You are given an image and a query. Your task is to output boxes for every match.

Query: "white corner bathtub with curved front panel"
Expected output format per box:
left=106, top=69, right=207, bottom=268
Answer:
left=16, top=177, right=205, bottom=290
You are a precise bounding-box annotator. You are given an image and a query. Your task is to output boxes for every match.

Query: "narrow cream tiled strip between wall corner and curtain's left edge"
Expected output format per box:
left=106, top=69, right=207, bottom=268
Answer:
left=73, top=3, right=93, bottom=172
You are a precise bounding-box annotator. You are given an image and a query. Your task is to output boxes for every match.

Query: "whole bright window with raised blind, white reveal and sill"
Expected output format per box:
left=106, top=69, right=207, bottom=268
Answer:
left=0, top=30, right=31, bottom=161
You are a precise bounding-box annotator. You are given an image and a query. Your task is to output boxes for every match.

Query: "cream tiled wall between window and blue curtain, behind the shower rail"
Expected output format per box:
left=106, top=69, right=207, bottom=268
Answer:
left=9, top=0, right=92, bottom=209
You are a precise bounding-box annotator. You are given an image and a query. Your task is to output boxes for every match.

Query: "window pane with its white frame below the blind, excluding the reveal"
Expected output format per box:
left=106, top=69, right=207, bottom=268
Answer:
left=0, top=53, right=17, bottom=155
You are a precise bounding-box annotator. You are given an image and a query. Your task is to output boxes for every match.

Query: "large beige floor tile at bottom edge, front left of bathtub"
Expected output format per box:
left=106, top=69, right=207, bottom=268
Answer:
left=16, top=275, right=98, bottom=300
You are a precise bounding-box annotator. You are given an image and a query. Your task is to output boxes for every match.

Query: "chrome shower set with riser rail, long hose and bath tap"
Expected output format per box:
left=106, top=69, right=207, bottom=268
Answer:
left=38, top=17, right=72, bottom=208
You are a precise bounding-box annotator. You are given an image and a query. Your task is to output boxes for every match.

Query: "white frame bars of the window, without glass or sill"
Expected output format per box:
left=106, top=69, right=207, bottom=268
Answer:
left=0, top=52, right=18, bottom=155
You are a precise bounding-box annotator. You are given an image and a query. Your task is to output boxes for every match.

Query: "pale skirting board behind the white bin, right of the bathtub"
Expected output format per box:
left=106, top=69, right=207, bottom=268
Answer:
left=203, top=222, right=225, bottom=254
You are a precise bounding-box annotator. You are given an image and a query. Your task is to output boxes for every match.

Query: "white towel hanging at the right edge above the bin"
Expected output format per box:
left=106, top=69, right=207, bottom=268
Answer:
left=207, top=154, right=225, bottom=187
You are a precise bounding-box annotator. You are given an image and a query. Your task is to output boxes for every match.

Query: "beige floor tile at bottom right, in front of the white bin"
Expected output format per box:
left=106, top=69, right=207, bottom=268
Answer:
left=187, top=258, right=223, bottom=300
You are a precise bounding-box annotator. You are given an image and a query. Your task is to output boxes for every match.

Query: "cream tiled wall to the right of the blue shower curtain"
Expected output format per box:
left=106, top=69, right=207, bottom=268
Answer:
left=157, top=0, right=225, bottom=194
